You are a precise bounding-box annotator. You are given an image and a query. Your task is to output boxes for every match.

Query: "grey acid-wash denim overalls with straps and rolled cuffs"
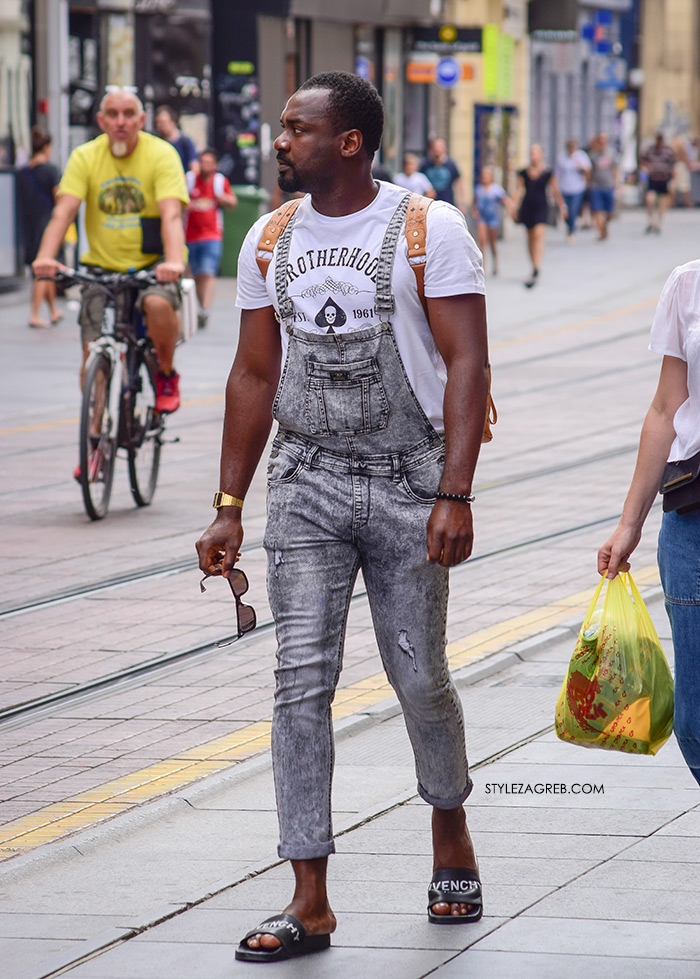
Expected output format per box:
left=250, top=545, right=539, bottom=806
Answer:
left=264, top=195, right=472, bottom=860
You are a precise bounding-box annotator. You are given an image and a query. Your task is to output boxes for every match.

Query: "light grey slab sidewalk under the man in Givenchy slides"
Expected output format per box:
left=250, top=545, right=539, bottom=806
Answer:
left=0, top=598, right=700, bottom=979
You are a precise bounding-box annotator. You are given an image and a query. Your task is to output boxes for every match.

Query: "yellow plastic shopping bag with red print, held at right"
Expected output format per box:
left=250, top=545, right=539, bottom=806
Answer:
left=555, top=573, right=673, bottom=755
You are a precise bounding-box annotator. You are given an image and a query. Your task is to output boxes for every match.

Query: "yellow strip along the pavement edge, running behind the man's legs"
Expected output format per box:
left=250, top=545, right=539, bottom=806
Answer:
left=0, top=565, right=658, bottom=860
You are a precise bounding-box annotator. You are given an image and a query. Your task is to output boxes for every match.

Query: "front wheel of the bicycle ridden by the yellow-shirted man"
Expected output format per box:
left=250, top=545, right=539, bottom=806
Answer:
left=80, top=354, right=118, bottom=520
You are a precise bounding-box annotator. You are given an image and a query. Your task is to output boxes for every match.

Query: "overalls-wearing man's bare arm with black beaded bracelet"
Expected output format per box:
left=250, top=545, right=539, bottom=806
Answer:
left=428, top=294, right=488, bottom=567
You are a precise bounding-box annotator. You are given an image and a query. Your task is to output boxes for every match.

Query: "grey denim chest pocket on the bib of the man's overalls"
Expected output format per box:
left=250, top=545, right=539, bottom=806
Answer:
left=304, top=357, right=389, bottom=436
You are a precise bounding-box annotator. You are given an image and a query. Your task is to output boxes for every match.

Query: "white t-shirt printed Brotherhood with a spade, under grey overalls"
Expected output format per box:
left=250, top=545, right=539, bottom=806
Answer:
left=236, top=181, right=485, bottom=432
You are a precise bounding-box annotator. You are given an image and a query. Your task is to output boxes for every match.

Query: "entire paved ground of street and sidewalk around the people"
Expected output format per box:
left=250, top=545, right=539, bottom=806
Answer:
left=0, top=205, right=700, bottom=979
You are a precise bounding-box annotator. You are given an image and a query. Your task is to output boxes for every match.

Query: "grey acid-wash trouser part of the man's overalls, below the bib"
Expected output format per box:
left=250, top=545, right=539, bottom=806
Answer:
left=264, top=436, right=472, bottom=860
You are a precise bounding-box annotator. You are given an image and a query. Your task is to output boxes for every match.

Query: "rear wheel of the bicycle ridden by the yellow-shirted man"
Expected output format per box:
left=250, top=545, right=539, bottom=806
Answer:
left=128, top=356, right=163, bottom=506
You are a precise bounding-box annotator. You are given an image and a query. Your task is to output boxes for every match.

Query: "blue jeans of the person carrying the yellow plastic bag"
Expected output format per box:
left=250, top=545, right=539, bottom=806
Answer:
left=659, top=510, right=700, bottom=783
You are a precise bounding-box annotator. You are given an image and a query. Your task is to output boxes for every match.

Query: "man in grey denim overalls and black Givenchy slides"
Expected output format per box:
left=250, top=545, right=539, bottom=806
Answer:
left=197, top=72, right=488, bottom=961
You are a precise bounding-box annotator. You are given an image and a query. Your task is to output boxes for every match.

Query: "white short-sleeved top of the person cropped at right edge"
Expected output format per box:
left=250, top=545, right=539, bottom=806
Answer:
left=649, top=259, right=700, bottom=462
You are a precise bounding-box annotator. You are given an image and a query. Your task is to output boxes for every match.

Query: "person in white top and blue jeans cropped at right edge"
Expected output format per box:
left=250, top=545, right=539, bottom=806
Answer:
left=598, top=259, right=700, bottom=783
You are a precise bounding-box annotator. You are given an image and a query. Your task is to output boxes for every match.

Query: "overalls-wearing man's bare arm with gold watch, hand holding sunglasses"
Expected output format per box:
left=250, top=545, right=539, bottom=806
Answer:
left=196, top=306, right=282, bottom=577
